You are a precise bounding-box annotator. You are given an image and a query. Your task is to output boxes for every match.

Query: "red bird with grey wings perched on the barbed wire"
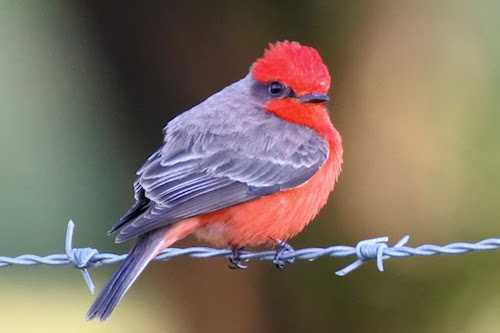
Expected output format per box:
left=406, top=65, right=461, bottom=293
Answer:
left=86, top=40, right=343, bottom=321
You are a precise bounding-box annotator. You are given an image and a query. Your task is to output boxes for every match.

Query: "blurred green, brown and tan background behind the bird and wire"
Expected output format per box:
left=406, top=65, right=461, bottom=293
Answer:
left=0, top=0, right=500, bottom=333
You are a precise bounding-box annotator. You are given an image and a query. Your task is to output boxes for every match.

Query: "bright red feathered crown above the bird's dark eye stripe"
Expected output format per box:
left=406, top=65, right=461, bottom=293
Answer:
left=251, top=41, right=330, bottom=96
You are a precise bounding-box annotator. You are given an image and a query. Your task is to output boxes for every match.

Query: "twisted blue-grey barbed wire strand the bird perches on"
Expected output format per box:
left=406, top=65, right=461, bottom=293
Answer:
left=0, top=220, right=500, bottom=293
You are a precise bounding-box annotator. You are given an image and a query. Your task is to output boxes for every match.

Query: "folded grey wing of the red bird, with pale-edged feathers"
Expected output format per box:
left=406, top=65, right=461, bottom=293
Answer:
left=112, top=76, right=328, bottom=242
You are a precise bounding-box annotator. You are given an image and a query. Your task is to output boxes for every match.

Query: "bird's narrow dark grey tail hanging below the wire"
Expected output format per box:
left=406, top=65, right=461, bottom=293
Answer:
left=86, top=229, right=166, bottom=321
